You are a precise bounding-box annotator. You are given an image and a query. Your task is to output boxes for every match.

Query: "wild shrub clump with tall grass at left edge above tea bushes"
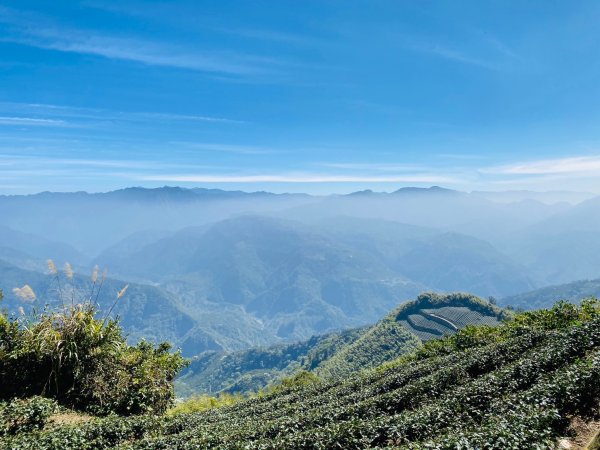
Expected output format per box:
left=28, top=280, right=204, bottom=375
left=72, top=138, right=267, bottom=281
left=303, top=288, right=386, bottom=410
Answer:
left=0, top=292, right=185, bottom=414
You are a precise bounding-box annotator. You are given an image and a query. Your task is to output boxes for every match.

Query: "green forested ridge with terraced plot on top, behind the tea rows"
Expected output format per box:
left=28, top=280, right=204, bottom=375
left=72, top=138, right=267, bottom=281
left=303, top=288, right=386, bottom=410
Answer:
left=177, top=293, right=508, bottom=396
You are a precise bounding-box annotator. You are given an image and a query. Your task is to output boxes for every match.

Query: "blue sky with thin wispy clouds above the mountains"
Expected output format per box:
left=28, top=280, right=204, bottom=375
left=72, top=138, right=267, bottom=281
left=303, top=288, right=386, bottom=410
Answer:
left=0, top=0, right=600, bottom=193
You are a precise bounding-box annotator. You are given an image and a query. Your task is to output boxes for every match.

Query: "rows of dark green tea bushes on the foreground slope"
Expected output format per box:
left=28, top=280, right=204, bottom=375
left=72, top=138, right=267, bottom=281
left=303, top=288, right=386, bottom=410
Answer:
left=0, top=301, right=600, bottom=450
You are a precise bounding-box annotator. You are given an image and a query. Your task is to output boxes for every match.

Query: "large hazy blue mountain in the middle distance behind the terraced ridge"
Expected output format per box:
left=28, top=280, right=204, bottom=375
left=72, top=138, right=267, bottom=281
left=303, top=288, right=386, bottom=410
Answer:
left=89, top=216, right=532, bottom=342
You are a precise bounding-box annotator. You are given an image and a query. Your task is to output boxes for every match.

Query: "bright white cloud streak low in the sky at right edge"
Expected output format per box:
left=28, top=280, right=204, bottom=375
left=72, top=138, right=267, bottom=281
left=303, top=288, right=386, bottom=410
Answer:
left=480, top=156, right=600, bottom=175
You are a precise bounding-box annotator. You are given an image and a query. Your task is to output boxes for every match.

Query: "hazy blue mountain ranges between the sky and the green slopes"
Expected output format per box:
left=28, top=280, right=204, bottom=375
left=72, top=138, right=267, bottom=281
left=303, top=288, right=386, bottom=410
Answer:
left=0, top=187, right=600, bottom=355
